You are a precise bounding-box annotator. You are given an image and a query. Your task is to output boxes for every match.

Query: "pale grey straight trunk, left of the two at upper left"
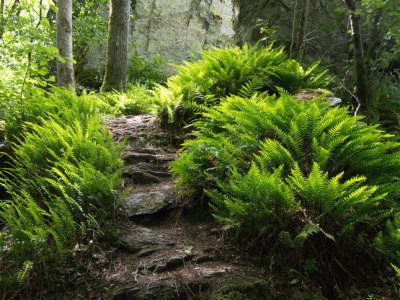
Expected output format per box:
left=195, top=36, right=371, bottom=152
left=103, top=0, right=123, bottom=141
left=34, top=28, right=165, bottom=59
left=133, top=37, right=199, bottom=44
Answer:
left=56, top=0, right=75, bottom=89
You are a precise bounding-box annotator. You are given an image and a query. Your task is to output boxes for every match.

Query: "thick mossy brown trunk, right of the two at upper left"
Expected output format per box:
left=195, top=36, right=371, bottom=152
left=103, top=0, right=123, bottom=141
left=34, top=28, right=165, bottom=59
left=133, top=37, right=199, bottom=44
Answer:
left=101, top=0, right=130, bottom=92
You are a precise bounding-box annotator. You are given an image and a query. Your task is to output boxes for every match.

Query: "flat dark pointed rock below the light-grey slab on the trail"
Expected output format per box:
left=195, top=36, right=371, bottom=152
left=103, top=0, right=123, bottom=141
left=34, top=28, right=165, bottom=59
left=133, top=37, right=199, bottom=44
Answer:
left=120, top=227, right=174, bottom=256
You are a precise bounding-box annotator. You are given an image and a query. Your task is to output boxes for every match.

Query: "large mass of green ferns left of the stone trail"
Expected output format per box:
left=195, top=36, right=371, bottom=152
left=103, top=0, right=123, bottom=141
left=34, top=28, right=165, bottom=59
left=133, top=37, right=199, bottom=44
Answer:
left=0, top=89, right=122, bottom=293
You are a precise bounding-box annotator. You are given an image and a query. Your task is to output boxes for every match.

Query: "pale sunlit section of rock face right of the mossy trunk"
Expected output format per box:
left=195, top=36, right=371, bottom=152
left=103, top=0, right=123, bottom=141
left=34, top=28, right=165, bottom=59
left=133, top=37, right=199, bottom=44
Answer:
left=130, top=0, right=234, bottom=69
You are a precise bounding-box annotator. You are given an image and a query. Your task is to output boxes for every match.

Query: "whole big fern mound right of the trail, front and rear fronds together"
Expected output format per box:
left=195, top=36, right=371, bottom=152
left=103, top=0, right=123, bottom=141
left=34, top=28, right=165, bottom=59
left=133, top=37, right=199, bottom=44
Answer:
left=172, top=93, right=400, bottom=264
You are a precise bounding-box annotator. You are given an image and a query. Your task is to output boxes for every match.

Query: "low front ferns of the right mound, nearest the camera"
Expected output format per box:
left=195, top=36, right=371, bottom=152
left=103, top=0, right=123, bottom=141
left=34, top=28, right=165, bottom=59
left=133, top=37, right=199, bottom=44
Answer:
left=207, top=163, right=391, bottom=246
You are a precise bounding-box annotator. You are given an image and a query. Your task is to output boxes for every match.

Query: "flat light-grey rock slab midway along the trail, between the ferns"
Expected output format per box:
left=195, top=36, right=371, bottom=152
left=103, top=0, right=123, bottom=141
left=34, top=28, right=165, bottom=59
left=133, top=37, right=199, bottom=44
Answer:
left=122, top=191, right=173, bottom=217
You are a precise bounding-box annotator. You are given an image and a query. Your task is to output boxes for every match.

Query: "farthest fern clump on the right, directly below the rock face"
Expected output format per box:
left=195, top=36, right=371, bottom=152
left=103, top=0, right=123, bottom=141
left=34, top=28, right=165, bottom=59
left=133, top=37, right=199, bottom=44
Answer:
left=156, top=45, right=329, bottom=128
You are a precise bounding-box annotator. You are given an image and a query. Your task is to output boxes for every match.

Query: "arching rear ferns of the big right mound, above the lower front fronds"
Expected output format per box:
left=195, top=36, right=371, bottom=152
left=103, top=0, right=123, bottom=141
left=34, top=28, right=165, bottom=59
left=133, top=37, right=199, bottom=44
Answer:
left=172, top=94, right=400, bottom=199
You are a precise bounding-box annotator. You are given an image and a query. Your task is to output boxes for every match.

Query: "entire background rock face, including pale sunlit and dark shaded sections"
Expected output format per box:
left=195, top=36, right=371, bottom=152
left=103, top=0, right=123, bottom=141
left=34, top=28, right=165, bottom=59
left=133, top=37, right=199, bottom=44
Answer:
left=84, top=0, right=348, bottom=77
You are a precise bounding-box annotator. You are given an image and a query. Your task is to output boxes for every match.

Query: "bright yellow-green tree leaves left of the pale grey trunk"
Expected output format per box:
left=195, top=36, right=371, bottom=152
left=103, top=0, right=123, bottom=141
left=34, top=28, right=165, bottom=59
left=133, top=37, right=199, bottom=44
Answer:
left=0, top=0, right=62, bottom=95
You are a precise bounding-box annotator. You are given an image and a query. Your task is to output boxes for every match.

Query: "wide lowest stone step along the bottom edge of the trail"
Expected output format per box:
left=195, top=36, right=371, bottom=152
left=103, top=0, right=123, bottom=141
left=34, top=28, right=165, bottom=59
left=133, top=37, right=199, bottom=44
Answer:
left=111, top=264, right=272, bottom=300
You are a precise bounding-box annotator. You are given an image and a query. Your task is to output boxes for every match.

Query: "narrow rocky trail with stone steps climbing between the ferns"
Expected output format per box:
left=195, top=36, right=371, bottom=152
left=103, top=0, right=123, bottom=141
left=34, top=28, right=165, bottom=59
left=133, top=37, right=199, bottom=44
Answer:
left=78, top=115, right=268, bottom=299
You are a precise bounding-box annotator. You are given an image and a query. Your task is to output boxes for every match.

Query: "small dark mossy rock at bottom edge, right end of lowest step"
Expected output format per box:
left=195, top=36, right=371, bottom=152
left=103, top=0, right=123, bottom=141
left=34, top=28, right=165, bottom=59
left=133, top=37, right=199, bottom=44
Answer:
left=211, top=278, right=277, bottom=300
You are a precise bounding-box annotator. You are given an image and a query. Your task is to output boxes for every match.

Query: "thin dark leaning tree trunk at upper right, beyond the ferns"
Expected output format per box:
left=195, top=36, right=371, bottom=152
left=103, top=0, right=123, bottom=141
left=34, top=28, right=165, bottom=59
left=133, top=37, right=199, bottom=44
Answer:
left=344, top=0, right=368, bottom=109
